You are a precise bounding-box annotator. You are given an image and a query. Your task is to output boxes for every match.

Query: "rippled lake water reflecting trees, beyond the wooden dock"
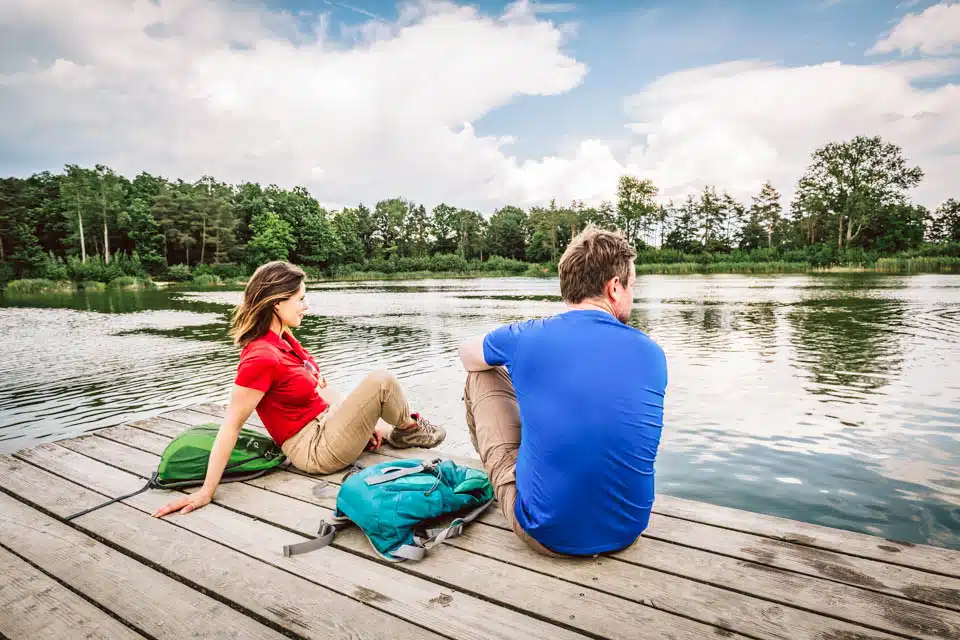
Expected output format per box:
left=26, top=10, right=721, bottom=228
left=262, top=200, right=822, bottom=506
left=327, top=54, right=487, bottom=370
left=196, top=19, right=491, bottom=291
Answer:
left=0, top=274, right=960, bottom=549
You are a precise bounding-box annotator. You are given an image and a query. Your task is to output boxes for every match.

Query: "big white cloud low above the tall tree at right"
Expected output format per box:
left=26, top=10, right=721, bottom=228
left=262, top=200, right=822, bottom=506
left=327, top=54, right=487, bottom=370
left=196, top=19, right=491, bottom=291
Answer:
left=627, top=60, right=960, bottom=204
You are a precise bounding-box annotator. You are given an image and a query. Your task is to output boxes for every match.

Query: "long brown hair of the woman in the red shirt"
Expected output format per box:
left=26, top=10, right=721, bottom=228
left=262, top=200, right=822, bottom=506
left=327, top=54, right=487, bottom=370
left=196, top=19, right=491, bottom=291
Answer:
left=230, top=260, right=306, bottom=348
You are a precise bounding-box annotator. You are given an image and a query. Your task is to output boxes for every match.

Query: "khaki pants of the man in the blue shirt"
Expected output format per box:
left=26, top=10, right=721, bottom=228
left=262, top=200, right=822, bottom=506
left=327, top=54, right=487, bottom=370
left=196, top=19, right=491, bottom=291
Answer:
left=463, top=367, right=564, bottom=557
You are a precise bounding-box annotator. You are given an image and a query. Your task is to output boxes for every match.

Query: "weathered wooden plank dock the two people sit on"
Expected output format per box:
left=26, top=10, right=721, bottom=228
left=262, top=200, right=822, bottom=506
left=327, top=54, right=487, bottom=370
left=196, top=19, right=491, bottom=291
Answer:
left=0, top=404, right=960, bottom=640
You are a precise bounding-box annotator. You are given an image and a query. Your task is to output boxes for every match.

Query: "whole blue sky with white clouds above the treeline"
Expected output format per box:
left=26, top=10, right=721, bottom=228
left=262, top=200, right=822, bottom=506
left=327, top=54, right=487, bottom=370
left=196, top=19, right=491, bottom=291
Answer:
left=0, top=0, right=960, bottom=215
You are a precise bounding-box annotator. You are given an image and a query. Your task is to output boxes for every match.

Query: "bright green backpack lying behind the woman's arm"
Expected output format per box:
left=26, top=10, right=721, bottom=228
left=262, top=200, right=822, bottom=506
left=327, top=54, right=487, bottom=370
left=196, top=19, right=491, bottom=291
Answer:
left=66, top=422, right=286, bottom=520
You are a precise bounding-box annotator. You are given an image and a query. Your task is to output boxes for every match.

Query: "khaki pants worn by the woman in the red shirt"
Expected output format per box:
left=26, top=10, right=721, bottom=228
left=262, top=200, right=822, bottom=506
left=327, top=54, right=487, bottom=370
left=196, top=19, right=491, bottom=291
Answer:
left=280, top=371, right=410, bottom=474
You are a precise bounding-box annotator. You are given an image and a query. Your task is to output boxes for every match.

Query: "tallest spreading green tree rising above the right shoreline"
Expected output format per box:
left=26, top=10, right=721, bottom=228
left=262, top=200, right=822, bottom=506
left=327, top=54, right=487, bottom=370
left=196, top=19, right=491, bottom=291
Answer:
left=794, top=136, right=923, bottom=249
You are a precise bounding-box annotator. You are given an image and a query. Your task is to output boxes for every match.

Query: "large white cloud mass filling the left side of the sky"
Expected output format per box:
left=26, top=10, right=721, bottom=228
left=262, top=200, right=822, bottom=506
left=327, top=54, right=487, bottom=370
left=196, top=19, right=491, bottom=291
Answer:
left=0, top=0, right=586, bottom=209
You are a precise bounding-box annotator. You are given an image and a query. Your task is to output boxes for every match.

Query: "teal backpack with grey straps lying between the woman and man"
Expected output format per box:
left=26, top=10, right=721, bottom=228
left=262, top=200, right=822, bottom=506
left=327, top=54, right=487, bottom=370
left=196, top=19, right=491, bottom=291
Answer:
left=283, top=458, right=493, bottom=562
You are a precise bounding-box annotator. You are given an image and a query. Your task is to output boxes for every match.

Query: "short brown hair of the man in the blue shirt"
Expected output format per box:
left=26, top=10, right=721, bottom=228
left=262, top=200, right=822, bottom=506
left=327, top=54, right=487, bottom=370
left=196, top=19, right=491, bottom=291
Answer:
left=558, top=225, right=637, bottom=304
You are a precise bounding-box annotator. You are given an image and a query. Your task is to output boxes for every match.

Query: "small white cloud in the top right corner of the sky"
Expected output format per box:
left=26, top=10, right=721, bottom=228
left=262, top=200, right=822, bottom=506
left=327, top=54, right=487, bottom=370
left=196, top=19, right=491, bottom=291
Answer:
left=867, top=2, right=960, bottom=55
